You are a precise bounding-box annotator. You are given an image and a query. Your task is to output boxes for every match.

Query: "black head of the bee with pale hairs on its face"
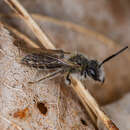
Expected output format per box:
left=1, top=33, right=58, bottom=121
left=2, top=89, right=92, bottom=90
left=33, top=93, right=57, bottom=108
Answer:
left=85, top=60, right=105, bottom=83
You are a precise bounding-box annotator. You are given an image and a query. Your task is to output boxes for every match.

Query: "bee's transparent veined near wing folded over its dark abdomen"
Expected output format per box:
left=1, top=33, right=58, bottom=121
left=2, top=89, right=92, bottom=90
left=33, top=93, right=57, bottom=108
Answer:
left=22, top=53, right=79, bottom=69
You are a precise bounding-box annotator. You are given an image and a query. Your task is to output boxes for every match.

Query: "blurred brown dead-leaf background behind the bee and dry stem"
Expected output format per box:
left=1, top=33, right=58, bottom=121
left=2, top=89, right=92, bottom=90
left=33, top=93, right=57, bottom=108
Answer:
left=0, top=0, right=130, bottom=130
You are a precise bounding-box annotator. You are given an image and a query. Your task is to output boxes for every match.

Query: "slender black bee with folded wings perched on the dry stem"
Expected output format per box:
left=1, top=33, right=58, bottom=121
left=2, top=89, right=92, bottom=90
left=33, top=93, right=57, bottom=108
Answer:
left=22, top=46, right=128, bottom=83
